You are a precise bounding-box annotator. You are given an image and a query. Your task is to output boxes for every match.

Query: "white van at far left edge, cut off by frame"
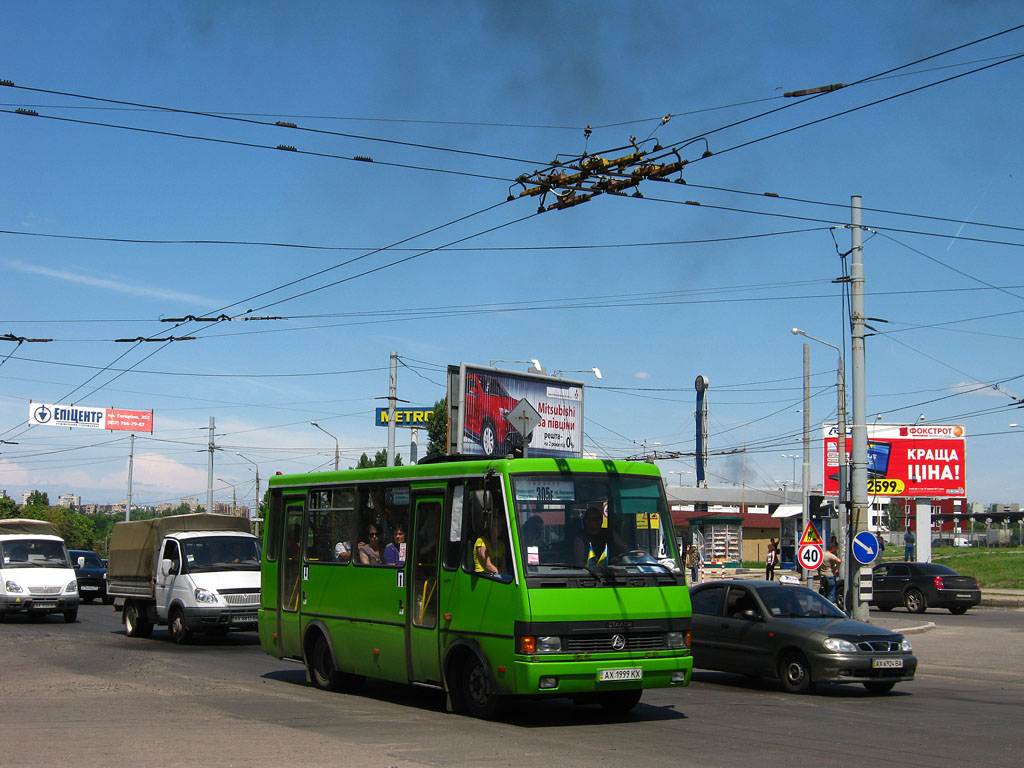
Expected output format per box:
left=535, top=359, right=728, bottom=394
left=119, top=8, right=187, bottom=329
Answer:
left=0, top=518, right=79, bottom=622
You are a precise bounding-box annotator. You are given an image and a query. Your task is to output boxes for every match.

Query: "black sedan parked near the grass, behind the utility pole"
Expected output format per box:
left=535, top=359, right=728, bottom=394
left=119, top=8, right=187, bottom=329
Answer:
left=870, top=562, right=981, bottom=613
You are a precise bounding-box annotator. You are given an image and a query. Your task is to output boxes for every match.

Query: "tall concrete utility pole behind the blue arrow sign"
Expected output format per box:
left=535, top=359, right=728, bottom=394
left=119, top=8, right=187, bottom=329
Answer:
left=847, top=195, right=878, bottom=622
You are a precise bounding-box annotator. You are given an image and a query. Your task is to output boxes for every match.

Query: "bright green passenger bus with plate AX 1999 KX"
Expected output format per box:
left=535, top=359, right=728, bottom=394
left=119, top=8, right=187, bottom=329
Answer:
left=259, top=457, right=693, bottom=718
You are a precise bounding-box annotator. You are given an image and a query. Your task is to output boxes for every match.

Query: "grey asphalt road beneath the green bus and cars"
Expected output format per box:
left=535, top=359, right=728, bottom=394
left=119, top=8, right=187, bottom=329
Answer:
left=0, top=605, right=1024, bottom=768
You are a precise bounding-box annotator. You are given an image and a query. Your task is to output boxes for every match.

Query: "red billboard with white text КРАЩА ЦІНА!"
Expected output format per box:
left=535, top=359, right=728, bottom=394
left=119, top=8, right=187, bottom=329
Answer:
left=822, top=424, right=967, bottom=499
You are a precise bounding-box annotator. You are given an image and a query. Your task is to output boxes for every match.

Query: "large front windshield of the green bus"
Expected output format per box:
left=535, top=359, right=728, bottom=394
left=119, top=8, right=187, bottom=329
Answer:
left=512, top=474, right=679, bottom=574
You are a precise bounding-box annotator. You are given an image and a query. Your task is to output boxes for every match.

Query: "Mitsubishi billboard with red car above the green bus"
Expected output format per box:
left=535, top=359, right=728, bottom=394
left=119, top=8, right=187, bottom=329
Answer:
left=449, top=362, right=584, bottom=459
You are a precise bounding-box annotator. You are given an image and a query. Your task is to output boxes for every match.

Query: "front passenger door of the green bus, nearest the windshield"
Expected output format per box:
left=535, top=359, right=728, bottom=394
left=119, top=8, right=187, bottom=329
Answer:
left=407, top=497, right=442, bottom=684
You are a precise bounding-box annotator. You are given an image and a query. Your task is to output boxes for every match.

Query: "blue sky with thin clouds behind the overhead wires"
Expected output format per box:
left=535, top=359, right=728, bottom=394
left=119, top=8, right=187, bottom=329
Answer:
left=0, top=0, right=1024, bottom=512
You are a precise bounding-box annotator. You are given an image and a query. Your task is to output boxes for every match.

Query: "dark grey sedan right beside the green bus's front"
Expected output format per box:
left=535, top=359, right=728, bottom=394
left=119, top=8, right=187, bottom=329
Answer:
left=690, top=581, right=918, bottom=693
